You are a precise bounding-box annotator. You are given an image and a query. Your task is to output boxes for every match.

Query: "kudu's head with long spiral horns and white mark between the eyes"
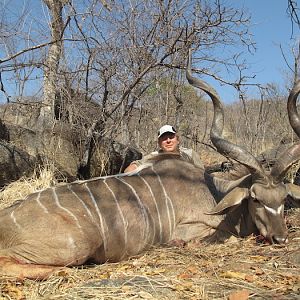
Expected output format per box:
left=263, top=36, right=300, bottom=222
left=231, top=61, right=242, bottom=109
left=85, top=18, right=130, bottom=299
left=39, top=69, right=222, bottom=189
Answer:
left=186, top=51, right=300, bottom=243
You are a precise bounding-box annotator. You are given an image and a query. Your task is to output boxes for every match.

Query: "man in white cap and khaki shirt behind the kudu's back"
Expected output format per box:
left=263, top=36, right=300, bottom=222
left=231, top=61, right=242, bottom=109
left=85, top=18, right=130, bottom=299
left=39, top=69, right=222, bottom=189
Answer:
left=124, top=125, right=204, bottom=172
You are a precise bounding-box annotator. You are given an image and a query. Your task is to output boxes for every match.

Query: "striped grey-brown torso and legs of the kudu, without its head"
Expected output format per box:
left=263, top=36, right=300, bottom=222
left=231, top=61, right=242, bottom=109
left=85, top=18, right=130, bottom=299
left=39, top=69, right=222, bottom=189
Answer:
left=0, top=154, right=226, bottom=278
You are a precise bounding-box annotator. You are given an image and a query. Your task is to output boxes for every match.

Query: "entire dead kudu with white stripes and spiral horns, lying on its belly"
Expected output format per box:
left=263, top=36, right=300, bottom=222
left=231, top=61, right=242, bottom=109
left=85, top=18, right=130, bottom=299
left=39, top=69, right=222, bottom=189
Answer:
left=0, top=53, right=299, bottom=278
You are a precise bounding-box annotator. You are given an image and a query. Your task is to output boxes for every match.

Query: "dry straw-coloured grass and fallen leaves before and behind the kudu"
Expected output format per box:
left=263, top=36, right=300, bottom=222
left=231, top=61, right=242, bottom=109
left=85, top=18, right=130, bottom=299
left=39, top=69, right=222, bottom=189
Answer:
left=0, top=170, right=300, bottom=300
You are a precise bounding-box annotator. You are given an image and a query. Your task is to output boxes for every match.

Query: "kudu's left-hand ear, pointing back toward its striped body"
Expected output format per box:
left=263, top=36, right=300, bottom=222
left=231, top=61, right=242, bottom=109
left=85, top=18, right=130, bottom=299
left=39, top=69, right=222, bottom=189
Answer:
left=205, top=187, right=249, bottom=215
